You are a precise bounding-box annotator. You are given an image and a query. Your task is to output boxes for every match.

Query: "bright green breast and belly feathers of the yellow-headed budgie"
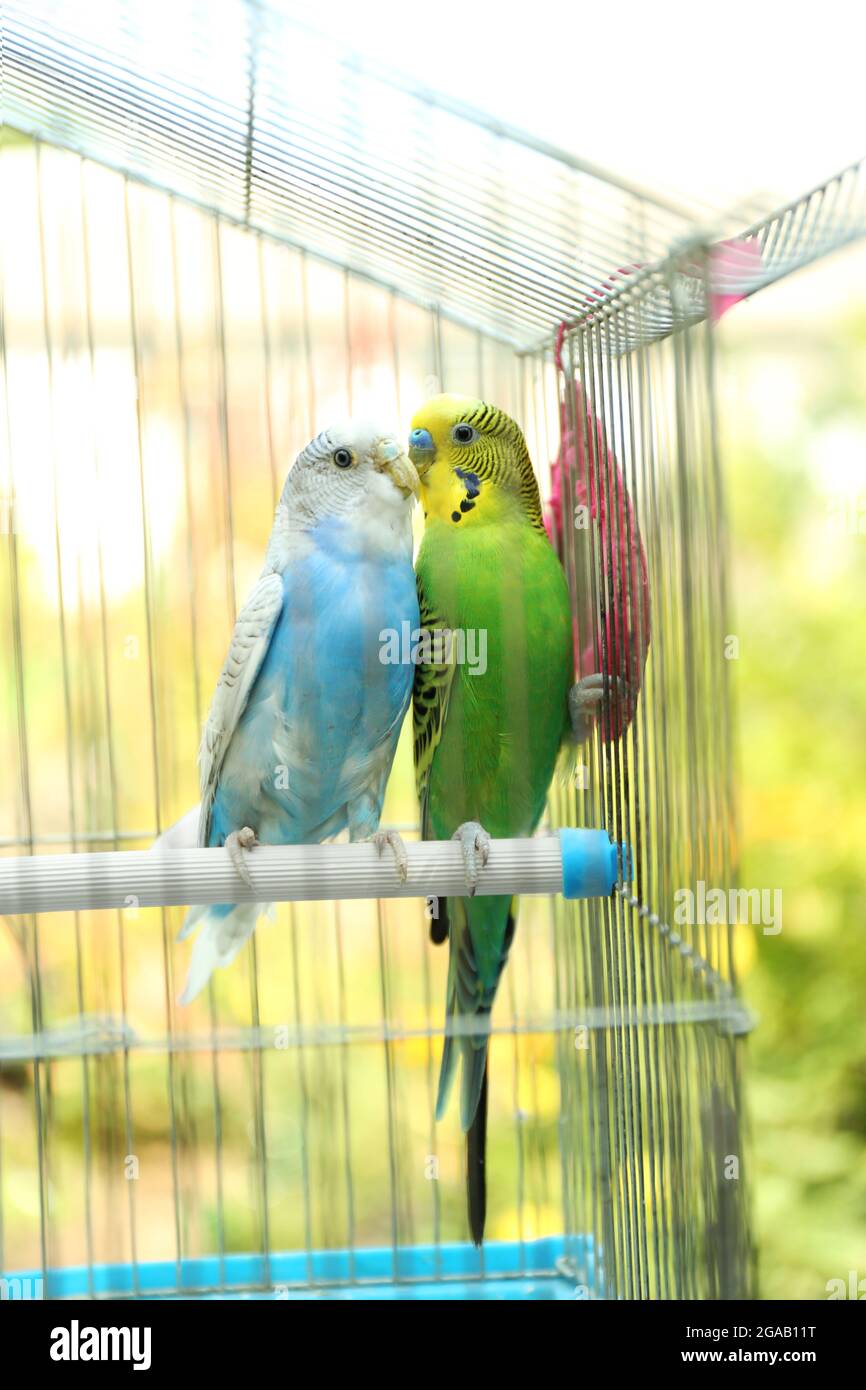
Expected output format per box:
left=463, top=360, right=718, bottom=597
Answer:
left=414, top=521, right=573, bottom=838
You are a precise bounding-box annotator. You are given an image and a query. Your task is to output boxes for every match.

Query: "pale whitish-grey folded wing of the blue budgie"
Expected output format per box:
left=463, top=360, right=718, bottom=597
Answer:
left=199, top=571, right=284, bottom=845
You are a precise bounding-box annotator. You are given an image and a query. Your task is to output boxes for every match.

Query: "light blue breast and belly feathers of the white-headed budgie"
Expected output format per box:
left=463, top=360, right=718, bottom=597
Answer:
left=209, top=528, right=418, bottom=845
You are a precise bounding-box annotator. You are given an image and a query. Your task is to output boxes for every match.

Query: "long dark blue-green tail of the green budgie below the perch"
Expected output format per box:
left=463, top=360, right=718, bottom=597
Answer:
left=436, top=898, right=514, bottom=1245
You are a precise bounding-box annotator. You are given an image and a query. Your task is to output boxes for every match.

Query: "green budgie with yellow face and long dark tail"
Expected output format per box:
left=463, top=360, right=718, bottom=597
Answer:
left=409, top=395, right=605, bottom=1245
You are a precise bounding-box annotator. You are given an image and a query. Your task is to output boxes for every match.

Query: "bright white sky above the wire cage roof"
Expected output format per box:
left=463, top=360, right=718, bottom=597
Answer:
left=281, top=0, right=865, bottom=207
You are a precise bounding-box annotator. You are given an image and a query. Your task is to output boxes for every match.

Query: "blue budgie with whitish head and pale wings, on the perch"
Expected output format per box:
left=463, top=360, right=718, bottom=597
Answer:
left=175, top=421, right=418, bottom=1004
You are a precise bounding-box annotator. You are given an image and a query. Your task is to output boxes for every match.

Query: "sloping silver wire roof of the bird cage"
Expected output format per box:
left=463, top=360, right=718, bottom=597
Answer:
left=6, top=0, right=866, bottom=348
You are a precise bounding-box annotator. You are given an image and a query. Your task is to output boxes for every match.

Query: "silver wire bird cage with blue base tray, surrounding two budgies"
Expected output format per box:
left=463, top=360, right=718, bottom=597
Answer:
left=0, top=0, right=866, bottom=1298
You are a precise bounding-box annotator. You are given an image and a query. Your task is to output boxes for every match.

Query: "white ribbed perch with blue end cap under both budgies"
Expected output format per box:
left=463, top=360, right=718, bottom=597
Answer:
left=0, top=830, right=628, bottom=916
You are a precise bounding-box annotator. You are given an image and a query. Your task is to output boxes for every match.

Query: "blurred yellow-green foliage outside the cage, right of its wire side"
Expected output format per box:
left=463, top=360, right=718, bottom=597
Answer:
left=721, top=284, right=866, bottom=1298
